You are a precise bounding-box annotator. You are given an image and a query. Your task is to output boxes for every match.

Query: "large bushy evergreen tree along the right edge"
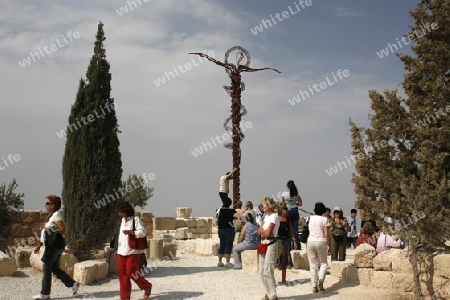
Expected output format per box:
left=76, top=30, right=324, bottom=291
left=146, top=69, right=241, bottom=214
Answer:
left=350, top=0, right=450, bottom=299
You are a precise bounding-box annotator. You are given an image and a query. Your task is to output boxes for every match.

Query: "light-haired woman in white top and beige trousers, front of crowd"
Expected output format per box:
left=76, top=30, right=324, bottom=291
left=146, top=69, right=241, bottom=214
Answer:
left=258, top=197, right=280, bottom=300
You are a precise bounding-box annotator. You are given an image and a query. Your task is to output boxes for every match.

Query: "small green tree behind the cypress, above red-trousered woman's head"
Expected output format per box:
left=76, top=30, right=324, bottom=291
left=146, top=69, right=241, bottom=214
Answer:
left=122, top=174, right=154, bottom=208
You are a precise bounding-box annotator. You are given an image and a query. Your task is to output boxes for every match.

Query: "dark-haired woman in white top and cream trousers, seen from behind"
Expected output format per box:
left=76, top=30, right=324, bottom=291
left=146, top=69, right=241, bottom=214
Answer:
left=306, top=202, right=331, bottom=293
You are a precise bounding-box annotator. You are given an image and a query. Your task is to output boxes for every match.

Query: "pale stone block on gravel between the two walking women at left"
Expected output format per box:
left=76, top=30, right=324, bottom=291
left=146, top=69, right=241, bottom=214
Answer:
left=73, top=260, right=109, bottom=285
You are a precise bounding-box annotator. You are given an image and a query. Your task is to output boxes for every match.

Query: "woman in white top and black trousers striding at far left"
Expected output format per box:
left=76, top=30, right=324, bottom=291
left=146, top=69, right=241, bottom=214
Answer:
left=33, top=195, right=80, bottom=300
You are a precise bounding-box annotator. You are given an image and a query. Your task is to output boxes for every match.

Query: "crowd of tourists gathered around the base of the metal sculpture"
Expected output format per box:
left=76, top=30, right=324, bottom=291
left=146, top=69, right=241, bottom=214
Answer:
left=214, top=170, right=402, bottom=300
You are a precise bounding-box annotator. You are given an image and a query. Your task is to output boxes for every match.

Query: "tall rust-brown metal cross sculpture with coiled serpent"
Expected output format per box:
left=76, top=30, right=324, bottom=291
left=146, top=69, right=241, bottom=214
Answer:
left=189, top=46, right=281, bottom=206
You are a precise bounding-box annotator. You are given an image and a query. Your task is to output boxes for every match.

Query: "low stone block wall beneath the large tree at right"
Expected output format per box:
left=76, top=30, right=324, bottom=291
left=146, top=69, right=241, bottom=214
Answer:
left=330, top=244, right=450, bottom=300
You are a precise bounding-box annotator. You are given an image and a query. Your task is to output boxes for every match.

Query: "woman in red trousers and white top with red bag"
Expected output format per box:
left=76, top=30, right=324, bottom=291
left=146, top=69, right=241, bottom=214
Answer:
left=116, top=202, right=152, bottom=300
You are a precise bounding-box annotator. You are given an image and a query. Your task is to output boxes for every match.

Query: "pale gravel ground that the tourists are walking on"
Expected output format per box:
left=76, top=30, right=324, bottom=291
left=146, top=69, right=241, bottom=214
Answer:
left=0, top=253, right=392, bottom=300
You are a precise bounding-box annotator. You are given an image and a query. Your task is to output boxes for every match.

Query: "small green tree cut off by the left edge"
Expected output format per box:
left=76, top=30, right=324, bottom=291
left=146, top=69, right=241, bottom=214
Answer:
left=0, top=178, right=25, bottom=244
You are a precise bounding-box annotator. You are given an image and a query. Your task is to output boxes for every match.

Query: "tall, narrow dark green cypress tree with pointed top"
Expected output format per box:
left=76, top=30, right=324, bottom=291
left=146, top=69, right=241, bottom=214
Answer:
left=62, top=22, right=122, bottom=261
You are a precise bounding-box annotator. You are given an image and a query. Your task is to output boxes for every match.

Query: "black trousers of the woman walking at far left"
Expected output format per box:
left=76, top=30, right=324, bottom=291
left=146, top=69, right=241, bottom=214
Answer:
left=41, top=247, right=75, bottom=295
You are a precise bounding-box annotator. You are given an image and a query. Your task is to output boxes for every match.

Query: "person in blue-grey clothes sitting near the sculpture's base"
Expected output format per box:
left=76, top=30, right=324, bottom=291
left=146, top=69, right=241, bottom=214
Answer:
left=233, top=210, right=260, bottom=270
